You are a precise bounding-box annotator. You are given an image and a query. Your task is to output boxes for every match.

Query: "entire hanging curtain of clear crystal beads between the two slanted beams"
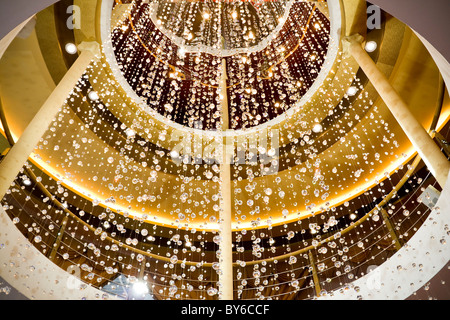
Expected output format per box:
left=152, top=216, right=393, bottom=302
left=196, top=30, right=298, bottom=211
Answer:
left=2, top=0, right=446, bottom=300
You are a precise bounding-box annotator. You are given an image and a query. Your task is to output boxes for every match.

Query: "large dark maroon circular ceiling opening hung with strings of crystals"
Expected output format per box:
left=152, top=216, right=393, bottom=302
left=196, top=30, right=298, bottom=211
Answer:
left=112, top=0, right=331, bottom=131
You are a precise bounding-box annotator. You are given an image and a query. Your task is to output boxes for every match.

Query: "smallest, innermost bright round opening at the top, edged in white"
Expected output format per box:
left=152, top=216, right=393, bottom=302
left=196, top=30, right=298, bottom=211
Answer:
left=148, top=0, right=293, bottom=57
